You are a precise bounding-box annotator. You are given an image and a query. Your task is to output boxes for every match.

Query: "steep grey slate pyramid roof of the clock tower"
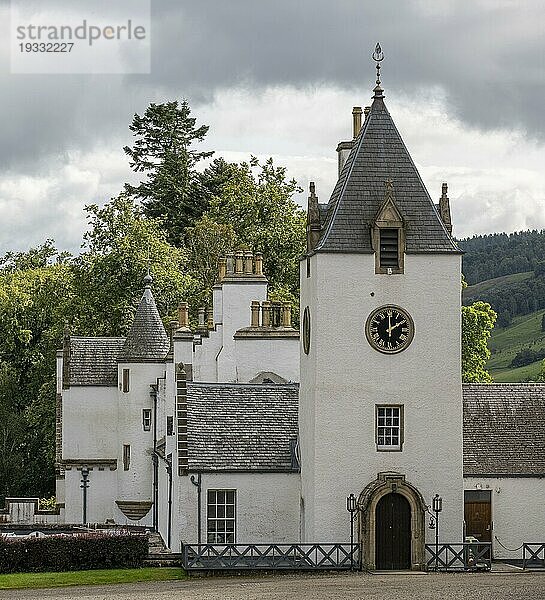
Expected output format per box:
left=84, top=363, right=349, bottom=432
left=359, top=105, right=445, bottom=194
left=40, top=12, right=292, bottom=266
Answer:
left=315, top=88, right=460, bottom=254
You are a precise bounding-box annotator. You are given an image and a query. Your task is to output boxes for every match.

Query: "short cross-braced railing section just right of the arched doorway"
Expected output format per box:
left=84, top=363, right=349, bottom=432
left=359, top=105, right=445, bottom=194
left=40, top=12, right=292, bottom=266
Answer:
left=426, top=542, right=492, bottom=571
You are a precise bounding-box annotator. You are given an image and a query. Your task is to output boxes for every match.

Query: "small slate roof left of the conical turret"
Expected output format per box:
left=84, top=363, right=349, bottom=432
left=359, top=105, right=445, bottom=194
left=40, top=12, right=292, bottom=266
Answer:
left=69, top=336, right=125, bottom=387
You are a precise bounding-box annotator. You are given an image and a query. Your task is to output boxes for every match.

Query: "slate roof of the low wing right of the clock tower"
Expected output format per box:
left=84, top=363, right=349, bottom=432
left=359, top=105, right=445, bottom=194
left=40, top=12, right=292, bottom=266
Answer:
left=463, top=383, right=545, bottom=476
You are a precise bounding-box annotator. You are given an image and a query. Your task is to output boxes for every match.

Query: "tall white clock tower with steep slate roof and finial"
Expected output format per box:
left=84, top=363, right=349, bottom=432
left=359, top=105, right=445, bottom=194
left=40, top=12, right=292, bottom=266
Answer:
left=299, top=54, right=463, bottom=569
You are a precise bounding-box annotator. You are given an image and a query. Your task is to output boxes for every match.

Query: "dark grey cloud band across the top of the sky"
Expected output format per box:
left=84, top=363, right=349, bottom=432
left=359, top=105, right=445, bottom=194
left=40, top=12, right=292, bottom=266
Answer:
left=0, top=0, right=545, bottom=172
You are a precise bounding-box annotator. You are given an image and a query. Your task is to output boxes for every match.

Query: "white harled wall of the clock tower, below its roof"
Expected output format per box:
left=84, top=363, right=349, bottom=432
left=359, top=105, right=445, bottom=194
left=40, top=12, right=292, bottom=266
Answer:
left=299, top=254, right=463, bottom=541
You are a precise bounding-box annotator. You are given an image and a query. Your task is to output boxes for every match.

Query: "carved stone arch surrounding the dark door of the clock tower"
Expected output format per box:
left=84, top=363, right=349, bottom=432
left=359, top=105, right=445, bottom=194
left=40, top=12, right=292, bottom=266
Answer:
left=358, top=472, right=426, bottom=571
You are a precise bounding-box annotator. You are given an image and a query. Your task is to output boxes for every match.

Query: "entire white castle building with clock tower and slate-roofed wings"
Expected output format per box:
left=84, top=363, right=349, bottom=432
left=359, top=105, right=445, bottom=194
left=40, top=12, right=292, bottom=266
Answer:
left=13, top=72, right=545, bottom=569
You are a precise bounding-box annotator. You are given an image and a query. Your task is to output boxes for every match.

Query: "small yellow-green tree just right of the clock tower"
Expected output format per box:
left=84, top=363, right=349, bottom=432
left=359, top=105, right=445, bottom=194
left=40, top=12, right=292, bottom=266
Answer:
left=462, top=302, right=497, bottom=383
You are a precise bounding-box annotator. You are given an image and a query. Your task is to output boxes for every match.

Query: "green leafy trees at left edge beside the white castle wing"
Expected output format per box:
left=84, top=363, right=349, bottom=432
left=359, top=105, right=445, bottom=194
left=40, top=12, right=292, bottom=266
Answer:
left=0, top=255, right=73, bottom=500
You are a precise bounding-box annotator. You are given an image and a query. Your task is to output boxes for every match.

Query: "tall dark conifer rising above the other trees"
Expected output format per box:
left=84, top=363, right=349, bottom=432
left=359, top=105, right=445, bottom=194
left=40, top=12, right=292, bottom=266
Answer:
left=124, top=100, right=212, bottom=246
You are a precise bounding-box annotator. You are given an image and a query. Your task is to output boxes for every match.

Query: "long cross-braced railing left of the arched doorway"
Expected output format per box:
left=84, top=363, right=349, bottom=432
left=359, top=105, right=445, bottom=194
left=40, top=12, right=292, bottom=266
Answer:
left=182, top=544, right=359, bottom=571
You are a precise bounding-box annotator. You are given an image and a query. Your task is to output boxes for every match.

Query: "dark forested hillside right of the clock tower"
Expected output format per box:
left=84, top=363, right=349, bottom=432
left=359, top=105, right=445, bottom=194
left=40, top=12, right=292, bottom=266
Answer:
left=459, top=230, right=545, bottom=327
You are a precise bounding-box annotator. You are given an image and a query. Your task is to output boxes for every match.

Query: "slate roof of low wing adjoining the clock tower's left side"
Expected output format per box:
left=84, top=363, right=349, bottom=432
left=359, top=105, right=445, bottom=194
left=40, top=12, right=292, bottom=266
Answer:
left=187, top=383, right=299, bottom=472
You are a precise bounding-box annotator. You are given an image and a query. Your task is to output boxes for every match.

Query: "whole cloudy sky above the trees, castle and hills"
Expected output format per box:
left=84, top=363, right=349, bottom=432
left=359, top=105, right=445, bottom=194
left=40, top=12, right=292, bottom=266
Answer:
left=0, top=0, right=545, bottom=252
